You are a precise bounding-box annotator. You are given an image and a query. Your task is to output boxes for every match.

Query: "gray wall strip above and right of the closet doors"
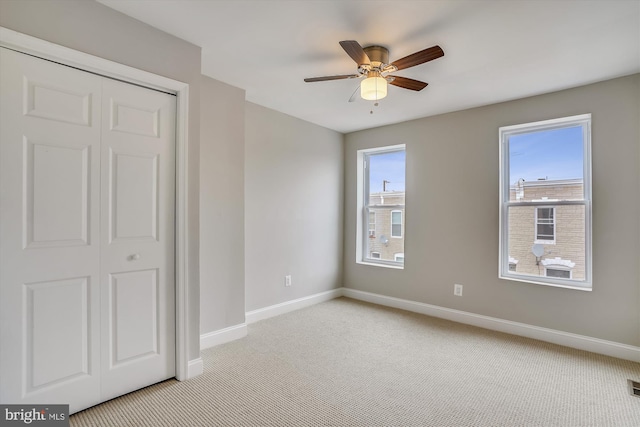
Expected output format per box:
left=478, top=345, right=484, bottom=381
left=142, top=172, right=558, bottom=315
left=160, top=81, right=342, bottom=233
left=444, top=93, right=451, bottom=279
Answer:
left=0, top=0, right=200, bottom=360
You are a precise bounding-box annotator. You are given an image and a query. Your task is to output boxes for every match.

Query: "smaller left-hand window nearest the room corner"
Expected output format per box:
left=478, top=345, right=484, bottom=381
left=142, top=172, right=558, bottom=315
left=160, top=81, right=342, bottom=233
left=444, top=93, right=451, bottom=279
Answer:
left=356, top=145, right=406, bottom=268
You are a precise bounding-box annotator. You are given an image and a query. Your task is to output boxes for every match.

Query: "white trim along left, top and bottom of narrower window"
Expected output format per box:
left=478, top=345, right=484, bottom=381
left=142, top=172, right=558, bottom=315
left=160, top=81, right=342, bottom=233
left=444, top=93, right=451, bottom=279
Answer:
left=356, top=144, right=406, bottom=270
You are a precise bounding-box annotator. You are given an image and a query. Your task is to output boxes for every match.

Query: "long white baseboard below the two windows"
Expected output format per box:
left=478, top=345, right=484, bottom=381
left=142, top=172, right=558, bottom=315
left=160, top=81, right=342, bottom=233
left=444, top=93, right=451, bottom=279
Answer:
left=342, top=288, right=640, bottom=362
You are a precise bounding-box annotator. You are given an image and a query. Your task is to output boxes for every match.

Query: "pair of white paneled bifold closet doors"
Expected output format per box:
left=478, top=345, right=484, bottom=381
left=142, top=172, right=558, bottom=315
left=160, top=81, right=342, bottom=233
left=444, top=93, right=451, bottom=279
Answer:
left=0, top=48, right=176, bottom=412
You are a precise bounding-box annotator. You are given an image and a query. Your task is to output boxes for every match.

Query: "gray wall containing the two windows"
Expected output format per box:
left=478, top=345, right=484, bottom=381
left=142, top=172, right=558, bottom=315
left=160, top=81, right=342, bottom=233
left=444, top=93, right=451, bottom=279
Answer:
left=344, top=75, right=640, bottom=346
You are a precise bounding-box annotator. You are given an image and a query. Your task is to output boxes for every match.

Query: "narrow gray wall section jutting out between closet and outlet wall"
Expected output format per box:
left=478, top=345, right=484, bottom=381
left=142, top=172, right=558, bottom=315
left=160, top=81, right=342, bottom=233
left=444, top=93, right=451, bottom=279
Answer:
left=200, top=76, right=245, bottom=334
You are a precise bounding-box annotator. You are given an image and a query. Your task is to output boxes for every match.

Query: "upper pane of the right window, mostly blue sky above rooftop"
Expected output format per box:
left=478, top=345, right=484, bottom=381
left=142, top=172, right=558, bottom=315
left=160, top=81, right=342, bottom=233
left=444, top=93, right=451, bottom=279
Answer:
left=508, top=126, right=584, bottom=201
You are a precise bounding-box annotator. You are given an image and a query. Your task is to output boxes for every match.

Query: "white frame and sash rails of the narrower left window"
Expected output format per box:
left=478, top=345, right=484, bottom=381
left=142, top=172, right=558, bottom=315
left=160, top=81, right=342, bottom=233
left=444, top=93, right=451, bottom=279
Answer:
left=356, top=144, right=407, bottom=270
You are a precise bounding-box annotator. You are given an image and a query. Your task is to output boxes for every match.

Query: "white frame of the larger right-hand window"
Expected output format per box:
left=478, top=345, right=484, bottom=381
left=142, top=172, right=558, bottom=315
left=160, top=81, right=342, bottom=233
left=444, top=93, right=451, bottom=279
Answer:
left=498, top=113, right=593, bottom=291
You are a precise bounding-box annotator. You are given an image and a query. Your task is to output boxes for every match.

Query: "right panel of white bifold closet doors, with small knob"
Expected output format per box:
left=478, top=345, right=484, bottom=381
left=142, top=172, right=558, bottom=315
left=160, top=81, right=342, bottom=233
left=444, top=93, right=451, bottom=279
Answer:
left=101, top=79, right=176, bottom=399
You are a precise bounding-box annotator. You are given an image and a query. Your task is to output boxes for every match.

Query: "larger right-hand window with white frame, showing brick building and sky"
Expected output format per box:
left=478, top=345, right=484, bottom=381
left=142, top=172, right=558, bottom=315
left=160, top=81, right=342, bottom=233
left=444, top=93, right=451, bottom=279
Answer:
left=499, top=114, right=592, bottom=290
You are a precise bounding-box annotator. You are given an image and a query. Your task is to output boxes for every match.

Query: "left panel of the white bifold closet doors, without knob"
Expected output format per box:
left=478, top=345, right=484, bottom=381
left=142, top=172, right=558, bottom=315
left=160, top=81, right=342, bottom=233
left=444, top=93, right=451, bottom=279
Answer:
left=0, top=48, right=101, bottom=411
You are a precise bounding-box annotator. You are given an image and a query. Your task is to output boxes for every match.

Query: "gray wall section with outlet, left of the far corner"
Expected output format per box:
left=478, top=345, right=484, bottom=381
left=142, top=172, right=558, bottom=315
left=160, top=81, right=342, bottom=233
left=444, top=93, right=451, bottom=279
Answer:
left=244, top=103, right=344, bottom=311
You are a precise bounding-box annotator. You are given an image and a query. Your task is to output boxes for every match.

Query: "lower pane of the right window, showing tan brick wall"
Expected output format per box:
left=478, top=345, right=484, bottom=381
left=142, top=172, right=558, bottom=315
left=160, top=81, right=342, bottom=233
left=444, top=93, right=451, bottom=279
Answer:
left=508, top=205, right=586, bottom=280
